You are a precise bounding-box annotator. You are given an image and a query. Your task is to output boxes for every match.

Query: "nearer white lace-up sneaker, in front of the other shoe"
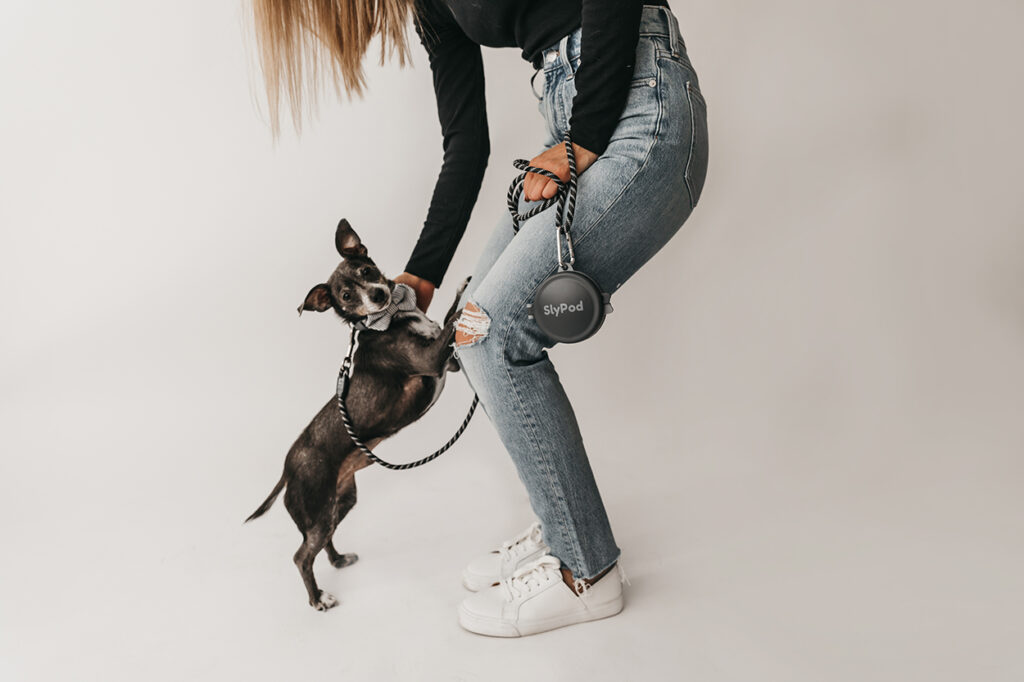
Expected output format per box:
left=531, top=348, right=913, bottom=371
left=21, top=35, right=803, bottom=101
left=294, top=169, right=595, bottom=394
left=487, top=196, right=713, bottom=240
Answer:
left=459, top=554, right=625, bottom=637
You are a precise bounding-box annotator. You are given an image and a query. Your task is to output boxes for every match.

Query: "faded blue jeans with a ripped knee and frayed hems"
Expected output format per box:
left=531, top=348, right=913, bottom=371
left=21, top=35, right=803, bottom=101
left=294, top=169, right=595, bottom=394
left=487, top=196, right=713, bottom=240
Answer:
left=456, top=6, right=708, bottom=579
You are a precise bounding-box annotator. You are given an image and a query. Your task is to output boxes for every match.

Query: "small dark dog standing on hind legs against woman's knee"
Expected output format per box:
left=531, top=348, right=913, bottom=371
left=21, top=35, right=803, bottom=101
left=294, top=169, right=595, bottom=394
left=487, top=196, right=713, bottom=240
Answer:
left=246, top=220, right=468, bottom=611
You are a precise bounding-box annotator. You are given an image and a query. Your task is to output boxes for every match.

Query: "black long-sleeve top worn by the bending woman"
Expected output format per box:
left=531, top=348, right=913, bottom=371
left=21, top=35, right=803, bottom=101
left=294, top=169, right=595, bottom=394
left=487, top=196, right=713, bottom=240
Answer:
left=406, top=0, right=668, bottom=286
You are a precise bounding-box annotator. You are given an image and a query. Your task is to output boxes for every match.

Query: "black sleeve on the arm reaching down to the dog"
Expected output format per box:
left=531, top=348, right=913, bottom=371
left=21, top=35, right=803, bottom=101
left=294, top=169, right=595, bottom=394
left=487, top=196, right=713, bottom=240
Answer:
left=406, top=0, right=490, bottom=287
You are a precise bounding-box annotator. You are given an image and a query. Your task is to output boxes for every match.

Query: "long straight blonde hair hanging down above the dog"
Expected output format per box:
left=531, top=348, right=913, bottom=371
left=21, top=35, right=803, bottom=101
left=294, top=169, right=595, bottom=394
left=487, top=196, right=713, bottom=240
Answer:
left=253, top=0, right=415, bottom=135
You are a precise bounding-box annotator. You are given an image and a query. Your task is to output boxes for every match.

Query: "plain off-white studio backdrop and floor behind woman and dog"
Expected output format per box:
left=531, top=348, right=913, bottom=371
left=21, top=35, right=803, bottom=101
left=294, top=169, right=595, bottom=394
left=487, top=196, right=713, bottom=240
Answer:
left=0, top=0, right=1024, bottom=682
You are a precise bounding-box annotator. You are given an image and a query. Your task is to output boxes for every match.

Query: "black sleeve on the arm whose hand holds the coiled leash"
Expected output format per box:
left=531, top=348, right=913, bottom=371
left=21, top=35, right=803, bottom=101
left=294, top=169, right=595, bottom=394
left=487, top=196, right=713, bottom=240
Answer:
left=569, top=0, right=644, bottom=154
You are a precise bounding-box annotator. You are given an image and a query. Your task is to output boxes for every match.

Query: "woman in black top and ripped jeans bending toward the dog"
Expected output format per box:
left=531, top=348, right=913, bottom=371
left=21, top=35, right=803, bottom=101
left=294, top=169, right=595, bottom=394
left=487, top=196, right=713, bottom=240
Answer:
left=256, top=0, right=708, bottom=636
